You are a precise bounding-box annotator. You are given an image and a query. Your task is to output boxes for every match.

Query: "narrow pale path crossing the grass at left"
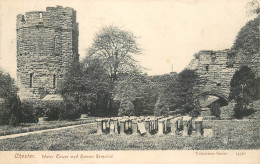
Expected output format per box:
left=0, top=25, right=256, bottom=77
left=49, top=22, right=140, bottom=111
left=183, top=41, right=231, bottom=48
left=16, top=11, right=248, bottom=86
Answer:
left=0, top=123, right=95, bottom=140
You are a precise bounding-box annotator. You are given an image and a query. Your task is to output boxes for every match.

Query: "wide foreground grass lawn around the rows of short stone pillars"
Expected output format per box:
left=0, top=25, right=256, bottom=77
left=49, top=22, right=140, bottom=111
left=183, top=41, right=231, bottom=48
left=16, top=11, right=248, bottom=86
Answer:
left=0, top=120, right=260, bottom=150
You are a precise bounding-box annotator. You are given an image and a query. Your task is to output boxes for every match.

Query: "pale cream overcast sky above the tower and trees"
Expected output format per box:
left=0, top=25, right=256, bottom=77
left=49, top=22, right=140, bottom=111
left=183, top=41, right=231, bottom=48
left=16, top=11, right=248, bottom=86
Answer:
left=0, top=0, right=252, bottom=77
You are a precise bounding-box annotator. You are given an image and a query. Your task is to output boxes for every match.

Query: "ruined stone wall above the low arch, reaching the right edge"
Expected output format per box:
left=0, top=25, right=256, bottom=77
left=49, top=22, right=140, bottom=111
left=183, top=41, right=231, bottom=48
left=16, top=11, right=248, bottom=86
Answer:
left=186, top=50, right=260, bottom=97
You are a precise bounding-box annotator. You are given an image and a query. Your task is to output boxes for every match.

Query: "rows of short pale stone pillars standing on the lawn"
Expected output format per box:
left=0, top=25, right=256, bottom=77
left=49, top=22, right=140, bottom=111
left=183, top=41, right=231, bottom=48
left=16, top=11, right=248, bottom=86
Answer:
left=96, top=116, right=207, bottom=136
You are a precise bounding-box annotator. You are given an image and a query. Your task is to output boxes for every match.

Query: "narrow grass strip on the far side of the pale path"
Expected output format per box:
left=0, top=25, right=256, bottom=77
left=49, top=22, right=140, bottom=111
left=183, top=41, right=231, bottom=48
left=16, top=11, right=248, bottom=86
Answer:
left=0, top=118, right=95, bottom=136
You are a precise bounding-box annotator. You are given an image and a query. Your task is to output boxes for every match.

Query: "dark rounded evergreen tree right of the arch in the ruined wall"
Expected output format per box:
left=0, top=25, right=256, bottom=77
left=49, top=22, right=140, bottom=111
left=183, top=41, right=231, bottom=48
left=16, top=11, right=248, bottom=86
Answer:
left=229, top=66, right=257, bottom=118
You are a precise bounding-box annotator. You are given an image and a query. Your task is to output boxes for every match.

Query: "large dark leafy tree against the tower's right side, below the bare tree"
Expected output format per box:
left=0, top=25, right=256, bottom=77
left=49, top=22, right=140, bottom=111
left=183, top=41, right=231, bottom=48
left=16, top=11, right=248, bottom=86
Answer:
left=60, top=57, right=113, bottom=116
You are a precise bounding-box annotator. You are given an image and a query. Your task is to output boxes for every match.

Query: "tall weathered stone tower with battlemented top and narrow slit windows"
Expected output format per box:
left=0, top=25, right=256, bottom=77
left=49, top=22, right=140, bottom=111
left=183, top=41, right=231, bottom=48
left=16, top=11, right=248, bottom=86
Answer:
left=16, top=6, right=79, bottom=99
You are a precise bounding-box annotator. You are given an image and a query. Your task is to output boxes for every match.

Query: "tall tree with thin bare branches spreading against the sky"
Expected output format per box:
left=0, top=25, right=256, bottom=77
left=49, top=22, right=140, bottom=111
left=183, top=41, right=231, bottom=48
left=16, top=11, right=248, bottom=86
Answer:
left=87, top=26, right=141, bottom=83
